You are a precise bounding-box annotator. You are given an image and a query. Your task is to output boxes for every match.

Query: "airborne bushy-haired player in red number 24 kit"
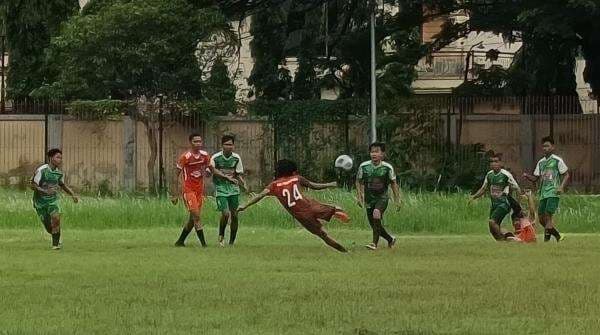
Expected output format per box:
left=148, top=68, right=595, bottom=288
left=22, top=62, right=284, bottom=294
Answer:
left=238, top=159, right=349, bottom=252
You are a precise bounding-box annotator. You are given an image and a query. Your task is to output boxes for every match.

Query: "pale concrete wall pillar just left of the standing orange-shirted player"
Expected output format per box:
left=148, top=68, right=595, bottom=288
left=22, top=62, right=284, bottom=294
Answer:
left=123, top=113, right=137, bottom=192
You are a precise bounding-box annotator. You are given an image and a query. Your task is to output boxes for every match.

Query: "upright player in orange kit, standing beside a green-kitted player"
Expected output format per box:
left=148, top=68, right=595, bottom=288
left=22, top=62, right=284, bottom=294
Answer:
left=171, top=134, right=237, bottom=247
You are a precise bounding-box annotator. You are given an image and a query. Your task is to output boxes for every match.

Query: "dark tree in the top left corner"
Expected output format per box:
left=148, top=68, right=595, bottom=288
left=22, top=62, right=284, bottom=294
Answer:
left=2, top=0, right=79, bottom=100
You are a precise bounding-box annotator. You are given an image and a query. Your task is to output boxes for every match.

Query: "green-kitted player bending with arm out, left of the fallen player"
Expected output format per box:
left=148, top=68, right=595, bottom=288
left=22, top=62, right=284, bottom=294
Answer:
left=471, top=154, right=521, bottom=241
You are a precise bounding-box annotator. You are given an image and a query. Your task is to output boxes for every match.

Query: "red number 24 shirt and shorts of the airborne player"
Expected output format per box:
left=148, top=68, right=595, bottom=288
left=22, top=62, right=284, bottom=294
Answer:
left=267, top=175, right=336, bottom=226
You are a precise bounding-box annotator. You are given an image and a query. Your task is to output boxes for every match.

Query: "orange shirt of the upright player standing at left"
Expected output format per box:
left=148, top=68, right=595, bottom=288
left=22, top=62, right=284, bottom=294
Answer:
left=177, top=150, right=210, bottom=193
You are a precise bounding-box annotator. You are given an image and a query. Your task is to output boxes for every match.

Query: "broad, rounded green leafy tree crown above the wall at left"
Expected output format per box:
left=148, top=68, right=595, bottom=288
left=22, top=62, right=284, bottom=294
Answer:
left=35, top=0, right=230, bottom=100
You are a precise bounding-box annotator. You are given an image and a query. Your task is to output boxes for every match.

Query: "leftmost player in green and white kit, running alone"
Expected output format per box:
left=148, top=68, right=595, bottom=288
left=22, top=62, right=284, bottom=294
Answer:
left=31, top=149, right=79, bottom=250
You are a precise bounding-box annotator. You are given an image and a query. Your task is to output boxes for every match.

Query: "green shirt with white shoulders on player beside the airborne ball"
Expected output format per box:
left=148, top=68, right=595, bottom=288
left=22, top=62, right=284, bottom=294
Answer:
left=356, top=161, right=396, bottom=204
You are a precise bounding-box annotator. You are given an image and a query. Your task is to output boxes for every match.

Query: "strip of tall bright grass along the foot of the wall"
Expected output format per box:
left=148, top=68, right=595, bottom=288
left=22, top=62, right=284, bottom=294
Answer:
left=0, top=190, right=600, bottom=234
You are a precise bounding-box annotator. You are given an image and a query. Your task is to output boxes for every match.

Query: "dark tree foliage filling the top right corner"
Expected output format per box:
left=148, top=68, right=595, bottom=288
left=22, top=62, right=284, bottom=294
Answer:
left=442, top=0, right=600, bottom=95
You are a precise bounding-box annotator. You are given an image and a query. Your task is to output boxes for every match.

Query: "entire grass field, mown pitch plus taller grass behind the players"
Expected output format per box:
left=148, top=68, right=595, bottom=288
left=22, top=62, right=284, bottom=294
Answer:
left=0, top=191, right=600, bottom=335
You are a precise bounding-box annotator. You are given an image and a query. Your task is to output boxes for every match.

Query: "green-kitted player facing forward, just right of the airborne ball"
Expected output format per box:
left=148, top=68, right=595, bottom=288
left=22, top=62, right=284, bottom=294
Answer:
left=356, top=142, right=400, bottom=250
